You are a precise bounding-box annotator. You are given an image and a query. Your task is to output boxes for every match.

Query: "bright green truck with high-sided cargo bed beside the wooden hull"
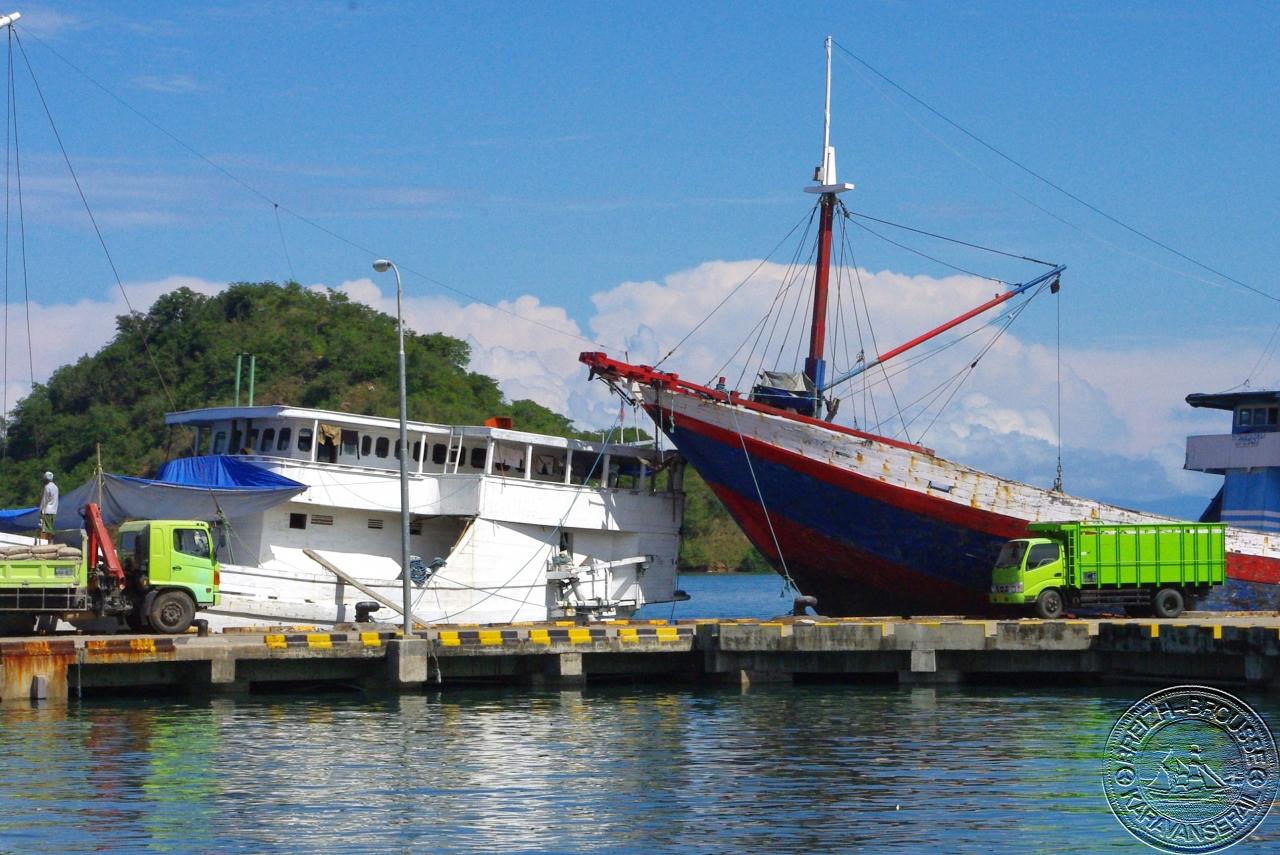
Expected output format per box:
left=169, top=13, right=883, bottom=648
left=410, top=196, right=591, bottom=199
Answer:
left=991, top=522, right=1226, bottom=618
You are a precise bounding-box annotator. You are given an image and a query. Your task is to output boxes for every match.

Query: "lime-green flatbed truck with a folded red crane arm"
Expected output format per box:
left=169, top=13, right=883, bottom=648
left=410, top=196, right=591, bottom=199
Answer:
left=0, top=504, right=220, bottom=635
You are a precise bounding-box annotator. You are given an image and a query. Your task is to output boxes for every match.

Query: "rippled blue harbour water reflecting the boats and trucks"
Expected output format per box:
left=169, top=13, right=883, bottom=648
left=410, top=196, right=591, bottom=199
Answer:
left=0, top=576, right=1280, bottom=852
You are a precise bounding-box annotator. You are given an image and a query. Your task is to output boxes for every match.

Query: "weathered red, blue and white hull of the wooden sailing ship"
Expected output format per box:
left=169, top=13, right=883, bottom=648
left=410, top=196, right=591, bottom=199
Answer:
left=650, top=396, right=1280, bottom=614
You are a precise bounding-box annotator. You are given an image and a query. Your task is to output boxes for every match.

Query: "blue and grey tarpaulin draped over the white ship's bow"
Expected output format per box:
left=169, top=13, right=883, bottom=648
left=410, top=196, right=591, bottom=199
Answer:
left=0, top=454, right=307, bottom=534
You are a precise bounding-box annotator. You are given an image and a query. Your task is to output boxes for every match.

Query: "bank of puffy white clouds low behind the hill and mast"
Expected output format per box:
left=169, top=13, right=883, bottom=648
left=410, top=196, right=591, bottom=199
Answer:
left=5, top=261, right=1233, bottom=514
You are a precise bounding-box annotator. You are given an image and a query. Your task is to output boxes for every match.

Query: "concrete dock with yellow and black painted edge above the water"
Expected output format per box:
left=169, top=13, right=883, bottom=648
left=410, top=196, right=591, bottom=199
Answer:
left=0, top=613, right=1280, bottom=704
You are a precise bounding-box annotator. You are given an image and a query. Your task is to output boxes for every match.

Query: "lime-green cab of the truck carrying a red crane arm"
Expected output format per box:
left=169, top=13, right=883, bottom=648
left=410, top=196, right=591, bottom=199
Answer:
left=119, top=520, right=221, bottom=632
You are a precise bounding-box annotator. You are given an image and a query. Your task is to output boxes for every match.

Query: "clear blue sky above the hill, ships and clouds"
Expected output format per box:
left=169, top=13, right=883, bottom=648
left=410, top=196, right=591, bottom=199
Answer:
left=6, top=1, right=1280, bottom=514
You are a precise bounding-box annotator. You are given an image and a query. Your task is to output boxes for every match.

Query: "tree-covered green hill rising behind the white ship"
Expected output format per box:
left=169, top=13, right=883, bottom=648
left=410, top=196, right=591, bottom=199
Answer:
left=0, top=283, right=765, bottom=570
